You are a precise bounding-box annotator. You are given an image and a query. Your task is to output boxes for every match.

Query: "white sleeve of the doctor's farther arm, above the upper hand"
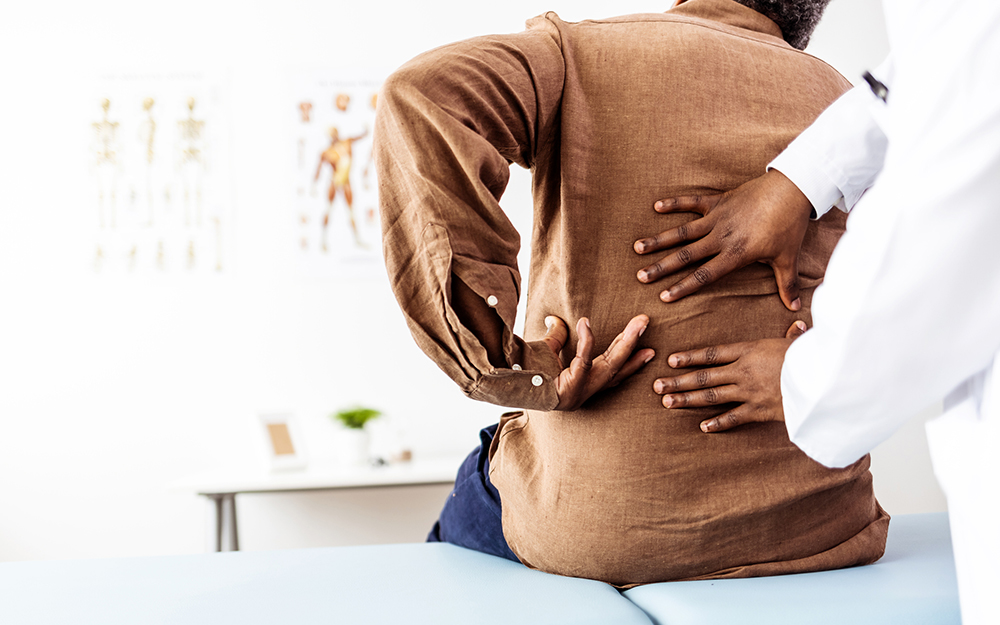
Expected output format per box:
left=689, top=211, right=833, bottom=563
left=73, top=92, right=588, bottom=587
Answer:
left=768, top=57, right=893, bottom=219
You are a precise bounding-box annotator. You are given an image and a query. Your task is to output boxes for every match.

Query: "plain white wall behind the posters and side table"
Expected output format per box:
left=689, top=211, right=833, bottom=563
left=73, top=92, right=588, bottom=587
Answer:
left=0, top=0, right=943, bottom=560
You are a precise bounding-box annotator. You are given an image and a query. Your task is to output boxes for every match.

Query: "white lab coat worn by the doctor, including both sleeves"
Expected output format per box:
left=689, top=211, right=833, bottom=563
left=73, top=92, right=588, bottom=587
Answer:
left=772, top=0, right=1000, bottom=625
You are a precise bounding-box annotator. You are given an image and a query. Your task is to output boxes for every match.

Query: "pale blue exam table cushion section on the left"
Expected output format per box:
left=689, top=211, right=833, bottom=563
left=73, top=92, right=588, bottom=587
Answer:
left=0, top=543, right=650, bottom=625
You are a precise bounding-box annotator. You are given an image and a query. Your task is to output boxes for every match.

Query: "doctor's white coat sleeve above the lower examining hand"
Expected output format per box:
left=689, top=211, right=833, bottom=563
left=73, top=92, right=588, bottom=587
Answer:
left=781, top=20, right=1000, bottom=467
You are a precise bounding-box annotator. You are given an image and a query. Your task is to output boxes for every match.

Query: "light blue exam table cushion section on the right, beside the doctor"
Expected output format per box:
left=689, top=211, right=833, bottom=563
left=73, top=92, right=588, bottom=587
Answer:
left=624, top=513, right=961, bottom=625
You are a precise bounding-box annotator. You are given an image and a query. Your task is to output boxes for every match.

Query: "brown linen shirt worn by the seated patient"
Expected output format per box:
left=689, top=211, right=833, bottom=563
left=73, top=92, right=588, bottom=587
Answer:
left=376, top=0, right=889, bottom=586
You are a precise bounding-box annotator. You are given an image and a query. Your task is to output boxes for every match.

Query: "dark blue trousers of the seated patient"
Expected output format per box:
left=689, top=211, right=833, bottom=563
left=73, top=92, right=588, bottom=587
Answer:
left=427, top=425, right=520, bottom=562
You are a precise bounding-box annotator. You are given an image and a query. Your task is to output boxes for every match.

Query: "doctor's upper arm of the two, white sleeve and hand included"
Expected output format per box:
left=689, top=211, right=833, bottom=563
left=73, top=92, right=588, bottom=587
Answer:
left=634, top=66, right=891, bottom=310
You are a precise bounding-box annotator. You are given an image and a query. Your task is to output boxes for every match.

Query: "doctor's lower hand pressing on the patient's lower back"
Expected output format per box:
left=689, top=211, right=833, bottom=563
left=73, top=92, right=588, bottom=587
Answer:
left=653, top=321, right=806, bottom=432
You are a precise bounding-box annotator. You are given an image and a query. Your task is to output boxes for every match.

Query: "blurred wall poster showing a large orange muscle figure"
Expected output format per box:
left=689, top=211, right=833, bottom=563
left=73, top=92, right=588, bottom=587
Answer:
left=288, top=70, right=382, bottom=277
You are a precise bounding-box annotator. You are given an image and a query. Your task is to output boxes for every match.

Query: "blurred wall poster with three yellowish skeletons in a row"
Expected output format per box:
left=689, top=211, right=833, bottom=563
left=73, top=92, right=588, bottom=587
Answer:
left=85, top=72, right=233, bottom=275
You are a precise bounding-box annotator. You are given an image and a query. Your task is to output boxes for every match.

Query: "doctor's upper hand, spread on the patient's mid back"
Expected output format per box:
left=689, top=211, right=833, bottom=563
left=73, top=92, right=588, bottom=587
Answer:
left=633, top=169, right=812, bottom=311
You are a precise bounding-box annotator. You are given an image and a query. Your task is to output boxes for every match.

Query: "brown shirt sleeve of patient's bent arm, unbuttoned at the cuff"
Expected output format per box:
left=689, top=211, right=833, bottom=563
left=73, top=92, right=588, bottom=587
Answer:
left=375, top=20, right=565, bottom=410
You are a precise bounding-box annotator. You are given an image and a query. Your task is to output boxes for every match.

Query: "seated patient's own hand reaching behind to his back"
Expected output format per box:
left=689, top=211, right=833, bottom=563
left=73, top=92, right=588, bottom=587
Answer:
left=543, top=315, right=655, bottom=410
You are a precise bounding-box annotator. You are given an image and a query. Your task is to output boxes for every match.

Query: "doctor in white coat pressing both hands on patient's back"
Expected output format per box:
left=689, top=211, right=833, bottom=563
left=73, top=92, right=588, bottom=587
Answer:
left=635, top=0, right=1000, bottom=625
